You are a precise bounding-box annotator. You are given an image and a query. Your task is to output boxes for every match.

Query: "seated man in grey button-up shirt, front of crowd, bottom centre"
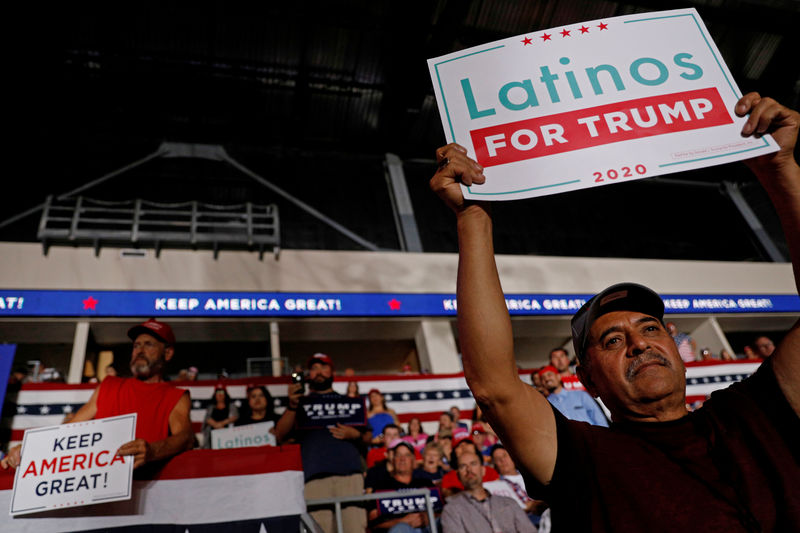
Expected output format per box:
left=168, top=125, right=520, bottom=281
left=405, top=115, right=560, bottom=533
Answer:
left=442, top=450, right=536, bottom=533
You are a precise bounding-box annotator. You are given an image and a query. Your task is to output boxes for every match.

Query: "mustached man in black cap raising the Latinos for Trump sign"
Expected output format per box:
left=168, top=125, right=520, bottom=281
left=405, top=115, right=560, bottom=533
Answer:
left=431, top=93, right=800, bottom=532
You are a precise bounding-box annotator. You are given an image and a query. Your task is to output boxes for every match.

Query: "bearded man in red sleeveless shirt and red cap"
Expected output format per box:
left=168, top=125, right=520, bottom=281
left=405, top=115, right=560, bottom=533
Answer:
left=2, top=318, right=193, bottom=468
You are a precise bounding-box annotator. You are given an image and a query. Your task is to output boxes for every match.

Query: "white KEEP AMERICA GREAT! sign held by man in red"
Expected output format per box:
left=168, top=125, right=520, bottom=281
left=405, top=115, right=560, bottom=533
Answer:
left=11, top=414, right=136, bottom=516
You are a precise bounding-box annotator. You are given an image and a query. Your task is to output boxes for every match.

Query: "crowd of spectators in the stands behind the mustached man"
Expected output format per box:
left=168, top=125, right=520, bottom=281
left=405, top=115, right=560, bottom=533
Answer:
left=0, top=320, right=774, bottom=533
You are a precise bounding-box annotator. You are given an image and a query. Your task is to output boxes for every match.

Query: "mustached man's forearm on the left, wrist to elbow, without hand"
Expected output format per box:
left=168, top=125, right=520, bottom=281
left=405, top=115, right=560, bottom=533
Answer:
left=457, top=205, right=519, bottom=397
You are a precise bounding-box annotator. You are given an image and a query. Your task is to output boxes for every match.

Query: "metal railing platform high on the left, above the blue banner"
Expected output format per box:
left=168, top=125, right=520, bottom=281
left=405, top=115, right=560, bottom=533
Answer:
left=37, top=195, right=280, bottom=257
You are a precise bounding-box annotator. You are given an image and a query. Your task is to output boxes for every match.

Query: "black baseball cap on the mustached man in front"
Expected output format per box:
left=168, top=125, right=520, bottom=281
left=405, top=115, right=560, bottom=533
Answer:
left=572, top=283, right=664, bottom=361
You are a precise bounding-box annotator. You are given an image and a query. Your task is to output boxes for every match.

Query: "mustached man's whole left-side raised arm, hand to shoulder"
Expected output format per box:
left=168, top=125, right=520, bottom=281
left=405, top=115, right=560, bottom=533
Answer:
left=430, top=144, right=556, bottom=483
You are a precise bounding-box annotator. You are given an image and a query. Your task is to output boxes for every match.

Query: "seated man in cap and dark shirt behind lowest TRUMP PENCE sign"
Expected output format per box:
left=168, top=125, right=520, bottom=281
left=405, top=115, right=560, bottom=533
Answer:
left=369, top=440, right=433, bottom=533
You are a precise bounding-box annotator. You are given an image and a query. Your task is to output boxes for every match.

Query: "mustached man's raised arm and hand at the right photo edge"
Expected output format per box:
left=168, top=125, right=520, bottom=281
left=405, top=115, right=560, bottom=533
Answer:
left=736, top=93, right=800, bottom=416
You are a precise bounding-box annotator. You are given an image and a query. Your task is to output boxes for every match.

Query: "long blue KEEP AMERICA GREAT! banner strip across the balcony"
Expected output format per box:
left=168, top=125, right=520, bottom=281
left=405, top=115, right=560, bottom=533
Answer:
left=0, top=290, right=800, bottom=317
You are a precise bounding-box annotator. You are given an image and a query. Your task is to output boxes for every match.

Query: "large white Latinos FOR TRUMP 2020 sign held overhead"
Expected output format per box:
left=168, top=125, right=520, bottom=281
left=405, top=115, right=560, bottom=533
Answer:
left=428, top=9, right=778, bottom=200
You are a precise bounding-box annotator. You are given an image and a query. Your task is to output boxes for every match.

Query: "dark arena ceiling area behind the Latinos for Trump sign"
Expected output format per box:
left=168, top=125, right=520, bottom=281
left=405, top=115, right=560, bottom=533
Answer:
left=0, top=0, right=800, bottom=260
